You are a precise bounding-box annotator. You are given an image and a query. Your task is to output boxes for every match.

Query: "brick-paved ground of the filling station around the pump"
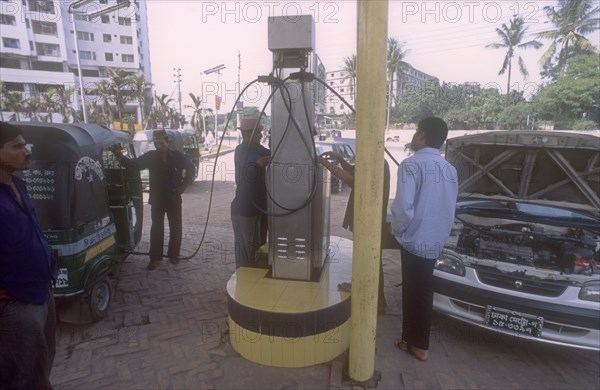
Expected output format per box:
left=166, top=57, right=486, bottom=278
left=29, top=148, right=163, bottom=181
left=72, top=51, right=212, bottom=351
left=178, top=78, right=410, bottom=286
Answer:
left=52, top=149, right=600, bottom=390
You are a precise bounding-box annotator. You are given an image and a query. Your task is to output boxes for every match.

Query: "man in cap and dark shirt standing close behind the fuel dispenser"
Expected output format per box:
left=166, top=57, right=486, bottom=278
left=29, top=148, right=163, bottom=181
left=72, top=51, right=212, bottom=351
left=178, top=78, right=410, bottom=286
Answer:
left=231, top=119, right=271, bottom=269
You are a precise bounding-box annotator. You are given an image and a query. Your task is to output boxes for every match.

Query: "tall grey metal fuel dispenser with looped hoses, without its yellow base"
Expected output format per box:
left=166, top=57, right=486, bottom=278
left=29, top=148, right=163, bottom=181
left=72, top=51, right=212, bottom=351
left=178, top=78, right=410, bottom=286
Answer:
left=267, top=15, right=330, bottom=280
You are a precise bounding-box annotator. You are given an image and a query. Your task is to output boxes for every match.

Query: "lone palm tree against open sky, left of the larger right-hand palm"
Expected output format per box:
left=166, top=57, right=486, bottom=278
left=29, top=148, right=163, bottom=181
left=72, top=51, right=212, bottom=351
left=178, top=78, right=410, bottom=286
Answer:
left=486, top=16, right=542, bottom=108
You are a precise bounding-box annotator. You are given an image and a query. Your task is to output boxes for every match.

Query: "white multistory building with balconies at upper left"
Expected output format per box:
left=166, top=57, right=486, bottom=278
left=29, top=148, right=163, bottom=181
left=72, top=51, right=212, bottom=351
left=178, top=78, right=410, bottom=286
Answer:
left=0, top=0, right=152, bottom=120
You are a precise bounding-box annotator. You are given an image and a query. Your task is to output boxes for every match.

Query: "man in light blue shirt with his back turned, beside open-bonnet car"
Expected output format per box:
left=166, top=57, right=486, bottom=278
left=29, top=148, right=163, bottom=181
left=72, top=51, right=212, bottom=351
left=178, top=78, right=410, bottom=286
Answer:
left=391, top=117, right=458, bottom=360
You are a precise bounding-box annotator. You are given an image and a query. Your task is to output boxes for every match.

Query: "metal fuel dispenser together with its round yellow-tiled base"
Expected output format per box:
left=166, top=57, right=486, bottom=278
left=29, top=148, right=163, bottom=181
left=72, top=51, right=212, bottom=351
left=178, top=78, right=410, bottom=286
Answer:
left=227, top=15, right=352, bottom=367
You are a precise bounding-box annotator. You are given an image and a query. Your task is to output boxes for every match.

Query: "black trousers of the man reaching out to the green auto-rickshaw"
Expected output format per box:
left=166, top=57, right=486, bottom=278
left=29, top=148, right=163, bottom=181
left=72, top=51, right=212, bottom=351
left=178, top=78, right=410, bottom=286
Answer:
left=150, top=202, right=183, bottom=261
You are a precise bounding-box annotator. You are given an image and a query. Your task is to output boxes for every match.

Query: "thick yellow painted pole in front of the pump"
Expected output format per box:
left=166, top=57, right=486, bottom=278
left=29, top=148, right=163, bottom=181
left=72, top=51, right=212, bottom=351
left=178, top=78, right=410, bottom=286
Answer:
left=349, top=0, right=388, bottom=382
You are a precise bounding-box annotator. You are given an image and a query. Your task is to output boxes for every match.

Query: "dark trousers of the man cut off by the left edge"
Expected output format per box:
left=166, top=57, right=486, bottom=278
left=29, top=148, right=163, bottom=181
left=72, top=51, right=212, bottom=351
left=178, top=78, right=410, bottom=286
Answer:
left=0, top=292, right=56, bottom=390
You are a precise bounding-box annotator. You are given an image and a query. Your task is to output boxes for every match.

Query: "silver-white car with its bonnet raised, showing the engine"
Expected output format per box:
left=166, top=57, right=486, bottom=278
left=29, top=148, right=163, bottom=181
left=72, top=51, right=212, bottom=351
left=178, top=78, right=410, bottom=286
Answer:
left=434, top=131, right=600, bottom=350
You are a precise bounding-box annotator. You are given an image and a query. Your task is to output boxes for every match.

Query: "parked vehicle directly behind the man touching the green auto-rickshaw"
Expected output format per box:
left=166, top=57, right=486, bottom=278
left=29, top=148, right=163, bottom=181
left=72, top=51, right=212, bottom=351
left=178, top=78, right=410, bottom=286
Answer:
left=133, top=129, right=200, bottom=188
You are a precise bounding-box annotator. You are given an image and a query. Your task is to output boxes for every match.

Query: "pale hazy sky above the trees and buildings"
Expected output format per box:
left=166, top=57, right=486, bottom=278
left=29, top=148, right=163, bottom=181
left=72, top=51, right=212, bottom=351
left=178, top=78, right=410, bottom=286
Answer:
left=146, top=0, right=599, bottom=115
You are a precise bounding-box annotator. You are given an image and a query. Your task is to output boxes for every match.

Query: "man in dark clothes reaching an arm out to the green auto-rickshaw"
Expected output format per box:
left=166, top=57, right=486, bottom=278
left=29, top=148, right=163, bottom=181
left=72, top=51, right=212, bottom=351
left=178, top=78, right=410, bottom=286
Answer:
left=114, top=130, right=195, bottom=270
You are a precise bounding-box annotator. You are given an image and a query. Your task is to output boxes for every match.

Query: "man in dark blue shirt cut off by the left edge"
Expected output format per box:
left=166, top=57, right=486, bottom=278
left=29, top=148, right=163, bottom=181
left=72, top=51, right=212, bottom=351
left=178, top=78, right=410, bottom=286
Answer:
left=0, top=122, right=57, bottom=389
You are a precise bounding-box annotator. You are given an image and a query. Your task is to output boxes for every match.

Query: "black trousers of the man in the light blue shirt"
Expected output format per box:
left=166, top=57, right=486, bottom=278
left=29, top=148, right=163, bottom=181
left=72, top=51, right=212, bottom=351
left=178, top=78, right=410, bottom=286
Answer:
left=400, top=248, right=435, bottom=349
